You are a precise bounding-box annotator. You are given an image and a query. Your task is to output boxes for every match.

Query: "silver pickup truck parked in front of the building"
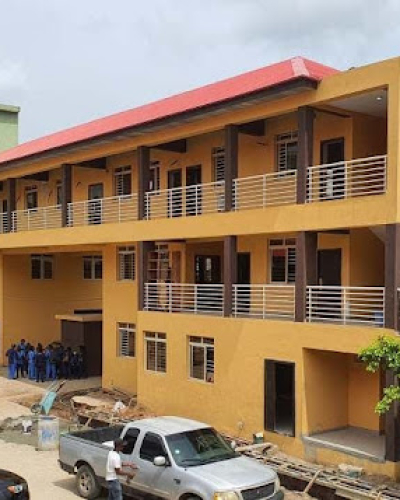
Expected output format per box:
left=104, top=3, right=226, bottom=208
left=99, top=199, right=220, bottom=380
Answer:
left=59, top=417, right=283, bottom=500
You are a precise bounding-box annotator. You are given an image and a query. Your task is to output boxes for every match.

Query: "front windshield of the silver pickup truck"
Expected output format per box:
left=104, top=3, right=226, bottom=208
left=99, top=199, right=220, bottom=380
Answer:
left=166, top=428, right=238, bottom=467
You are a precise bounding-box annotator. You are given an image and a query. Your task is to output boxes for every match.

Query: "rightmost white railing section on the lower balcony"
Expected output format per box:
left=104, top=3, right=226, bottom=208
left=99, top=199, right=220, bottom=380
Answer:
left=307, top=286, right=385, bottom=327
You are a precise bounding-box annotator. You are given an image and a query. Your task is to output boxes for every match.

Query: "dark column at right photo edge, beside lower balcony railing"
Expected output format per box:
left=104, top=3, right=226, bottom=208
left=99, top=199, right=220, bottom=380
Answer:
left=385, top=224, right=400, bottom=330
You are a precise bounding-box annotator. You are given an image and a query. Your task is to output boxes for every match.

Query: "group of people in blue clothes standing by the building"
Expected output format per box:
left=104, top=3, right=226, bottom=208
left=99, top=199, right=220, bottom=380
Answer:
left=6, top=339, right=87, bottom=382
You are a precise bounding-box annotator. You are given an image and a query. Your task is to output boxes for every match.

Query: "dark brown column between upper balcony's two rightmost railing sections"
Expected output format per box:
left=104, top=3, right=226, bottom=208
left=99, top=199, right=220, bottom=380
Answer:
left=297, top=106, right=314, bottom=203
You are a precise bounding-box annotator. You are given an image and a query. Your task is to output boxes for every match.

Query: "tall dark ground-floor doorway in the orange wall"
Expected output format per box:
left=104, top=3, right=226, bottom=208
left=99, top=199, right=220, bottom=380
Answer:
left=265, top=359, right=296, bottom=436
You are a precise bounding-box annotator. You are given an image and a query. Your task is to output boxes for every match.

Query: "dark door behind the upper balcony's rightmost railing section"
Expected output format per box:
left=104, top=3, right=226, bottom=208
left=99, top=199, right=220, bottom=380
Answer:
left=319, top=137, right=346, bottom=200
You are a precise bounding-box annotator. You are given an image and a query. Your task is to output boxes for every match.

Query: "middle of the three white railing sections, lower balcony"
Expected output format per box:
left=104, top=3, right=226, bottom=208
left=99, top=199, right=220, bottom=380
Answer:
left=233, top=285, right=295, bottom=320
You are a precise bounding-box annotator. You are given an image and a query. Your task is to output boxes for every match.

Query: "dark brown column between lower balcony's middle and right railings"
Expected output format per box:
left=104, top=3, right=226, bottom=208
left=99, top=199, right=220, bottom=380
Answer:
left=295, top=231, right=318, bottom=323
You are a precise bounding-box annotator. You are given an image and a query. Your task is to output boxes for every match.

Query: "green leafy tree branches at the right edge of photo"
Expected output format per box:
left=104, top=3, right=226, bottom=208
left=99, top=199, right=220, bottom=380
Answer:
left=358, top=336, right=400, bottom=415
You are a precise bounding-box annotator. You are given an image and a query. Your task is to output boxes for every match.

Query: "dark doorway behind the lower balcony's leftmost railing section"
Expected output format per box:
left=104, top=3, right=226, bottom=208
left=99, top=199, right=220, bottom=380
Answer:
left=195, top=255, right=222, bottom=311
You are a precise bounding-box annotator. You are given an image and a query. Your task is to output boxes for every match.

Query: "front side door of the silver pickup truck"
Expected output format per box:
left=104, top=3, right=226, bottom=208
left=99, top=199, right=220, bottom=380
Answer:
left=132, top=432, right=183, bottom=498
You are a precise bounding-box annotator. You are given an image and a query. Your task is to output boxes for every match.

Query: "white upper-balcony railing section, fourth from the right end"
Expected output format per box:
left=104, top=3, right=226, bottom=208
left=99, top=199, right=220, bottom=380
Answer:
left=68, top=194, right=138, bottom=226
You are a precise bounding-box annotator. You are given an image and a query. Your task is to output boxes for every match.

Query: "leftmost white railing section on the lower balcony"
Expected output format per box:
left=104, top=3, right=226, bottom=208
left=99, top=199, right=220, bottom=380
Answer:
left=144, top=283, right=224, bottom=316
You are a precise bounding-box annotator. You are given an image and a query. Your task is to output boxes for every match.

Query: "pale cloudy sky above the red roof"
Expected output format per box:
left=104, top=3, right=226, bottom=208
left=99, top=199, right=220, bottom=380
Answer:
left=0, top=0, right=400, bottom=142
